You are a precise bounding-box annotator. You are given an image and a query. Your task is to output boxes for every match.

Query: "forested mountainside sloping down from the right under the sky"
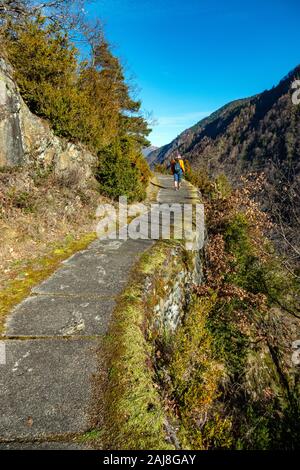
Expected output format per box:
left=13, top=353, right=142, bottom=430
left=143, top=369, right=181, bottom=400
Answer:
left=148, top=65, right=300, bottom=258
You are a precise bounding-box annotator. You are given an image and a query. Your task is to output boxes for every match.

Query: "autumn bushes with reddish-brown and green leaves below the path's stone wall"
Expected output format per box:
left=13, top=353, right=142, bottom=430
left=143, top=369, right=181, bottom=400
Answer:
left=164, top=169, right=300, bottom=450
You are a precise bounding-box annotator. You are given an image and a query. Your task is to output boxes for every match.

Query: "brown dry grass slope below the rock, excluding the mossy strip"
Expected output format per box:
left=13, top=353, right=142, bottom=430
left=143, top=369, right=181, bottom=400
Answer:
left=0, top=169, right=103, bottom=289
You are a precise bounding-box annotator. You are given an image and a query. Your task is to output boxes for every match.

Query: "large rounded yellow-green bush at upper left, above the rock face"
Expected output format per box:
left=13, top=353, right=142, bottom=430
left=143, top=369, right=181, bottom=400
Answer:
left=6, top=19, right=86, bottom=138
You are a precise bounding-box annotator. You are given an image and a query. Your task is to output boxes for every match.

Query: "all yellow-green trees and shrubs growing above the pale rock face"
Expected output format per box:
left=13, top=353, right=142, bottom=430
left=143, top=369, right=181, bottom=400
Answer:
left=3, top=17, right=150, bottom=201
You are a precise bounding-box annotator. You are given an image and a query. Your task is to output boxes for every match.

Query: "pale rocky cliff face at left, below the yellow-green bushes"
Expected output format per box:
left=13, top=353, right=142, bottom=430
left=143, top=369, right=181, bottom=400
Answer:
left=0, top=57, right=96, bottom=183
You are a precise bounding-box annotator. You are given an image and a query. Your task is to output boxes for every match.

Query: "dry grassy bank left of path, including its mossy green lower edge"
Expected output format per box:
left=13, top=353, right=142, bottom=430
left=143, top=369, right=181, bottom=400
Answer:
left=0, top=168, right=109, bottom=331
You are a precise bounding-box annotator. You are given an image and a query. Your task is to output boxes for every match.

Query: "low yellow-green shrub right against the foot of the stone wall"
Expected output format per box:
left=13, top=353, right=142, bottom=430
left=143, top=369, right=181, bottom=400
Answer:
left=169, top=297, right=232, bottom=450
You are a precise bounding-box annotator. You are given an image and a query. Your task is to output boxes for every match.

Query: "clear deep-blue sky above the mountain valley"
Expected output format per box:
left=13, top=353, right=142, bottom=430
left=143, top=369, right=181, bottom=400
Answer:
left=88, top=0, right=300, bottom=146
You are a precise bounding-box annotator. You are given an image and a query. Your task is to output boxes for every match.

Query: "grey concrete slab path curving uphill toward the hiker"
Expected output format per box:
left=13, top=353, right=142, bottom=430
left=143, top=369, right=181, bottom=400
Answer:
left=0, top=176, right=197, bottom=449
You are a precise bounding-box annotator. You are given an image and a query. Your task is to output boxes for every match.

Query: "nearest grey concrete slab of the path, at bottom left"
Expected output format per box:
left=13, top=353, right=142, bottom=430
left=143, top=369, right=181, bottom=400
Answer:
left=0, top=339, right=99, bottom=439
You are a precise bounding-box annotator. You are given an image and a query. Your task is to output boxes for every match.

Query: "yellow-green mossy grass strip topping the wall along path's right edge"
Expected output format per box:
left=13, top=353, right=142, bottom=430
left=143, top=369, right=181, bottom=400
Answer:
left=105, top=242, right=180, bottom=450
